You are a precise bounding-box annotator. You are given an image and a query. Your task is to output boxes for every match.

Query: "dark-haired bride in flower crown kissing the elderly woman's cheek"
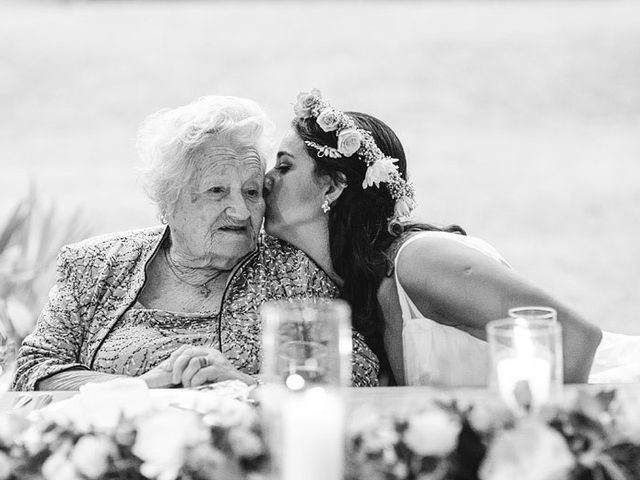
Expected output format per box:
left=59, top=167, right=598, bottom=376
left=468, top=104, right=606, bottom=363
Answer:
left=265, top=90, right=640, bottom=386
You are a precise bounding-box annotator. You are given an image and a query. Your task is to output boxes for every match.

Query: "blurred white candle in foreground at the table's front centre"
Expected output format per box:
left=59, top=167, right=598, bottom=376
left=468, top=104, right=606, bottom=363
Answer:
left=280, top=387, right=344, bottom=480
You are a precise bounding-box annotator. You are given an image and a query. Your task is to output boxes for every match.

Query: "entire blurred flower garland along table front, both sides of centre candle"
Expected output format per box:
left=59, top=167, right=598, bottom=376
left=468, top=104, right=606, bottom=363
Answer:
left=0, top=389, right=640, bottom=480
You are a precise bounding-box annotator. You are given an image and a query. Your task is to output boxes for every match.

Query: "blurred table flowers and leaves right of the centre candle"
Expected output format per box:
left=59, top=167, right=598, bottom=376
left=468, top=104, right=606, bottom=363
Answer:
left=347, top=390, right=640, bottom=480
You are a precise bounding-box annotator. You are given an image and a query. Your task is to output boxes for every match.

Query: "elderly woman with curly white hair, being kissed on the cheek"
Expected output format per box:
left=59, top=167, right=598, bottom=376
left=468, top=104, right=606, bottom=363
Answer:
left=14, top=96, right=378, bottom=390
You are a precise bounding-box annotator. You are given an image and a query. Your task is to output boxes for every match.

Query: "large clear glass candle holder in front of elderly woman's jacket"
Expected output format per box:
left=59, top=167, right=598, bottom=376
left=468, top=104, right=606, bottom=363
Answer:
left=259, top=300, right=351, bottom=480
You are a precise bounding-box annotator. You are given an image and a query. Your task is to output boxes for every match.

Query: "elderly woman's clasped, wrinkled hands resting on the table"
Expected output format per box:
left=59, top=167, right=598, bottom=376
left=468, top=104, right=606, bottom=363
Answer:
left=141, top=345, right=256, bottom=388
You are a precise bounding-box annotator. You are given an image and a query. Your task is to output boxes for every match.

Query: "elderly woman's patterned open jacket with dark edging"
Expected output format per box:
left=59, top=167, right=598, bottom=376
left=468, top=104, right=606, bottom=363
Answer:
left=13, top=227, right=378, bottom=390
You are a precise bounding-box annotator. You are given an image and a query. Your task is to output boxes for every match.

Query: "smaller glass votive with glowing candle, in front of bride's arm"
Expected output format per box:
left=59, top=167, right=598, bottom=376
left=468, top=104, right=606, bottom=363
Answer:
left=487, top=317, right=562, bottom=415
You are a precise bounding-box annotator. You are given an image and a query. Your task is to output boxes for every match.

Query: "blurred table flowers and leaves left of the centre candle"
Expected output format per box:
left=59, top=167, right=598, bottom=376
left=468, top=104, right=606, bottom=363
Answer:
left=0, top=400, right=268, bottom=480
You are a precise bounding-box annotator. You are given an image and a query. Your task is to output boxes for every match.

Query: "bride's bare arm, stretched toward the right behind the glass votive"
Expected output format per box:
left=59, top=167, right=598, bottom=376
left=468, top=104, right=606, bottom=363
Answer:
left=397, top=237, right=602, bottom=383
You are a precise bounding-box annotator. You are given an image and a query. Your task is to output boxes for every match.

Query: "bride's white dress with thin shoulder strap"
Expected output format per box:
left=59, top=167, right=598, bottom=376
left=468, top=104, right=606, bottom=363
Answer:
left=395, top=231, right=640, bottom=386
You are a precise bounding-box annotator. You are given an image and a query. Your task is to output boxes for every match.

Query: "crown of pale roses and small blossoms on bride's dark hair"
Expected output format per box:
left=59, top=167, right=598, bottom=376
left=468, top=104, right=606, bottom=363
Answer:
left=293, top=89, right=415, bottom=221
